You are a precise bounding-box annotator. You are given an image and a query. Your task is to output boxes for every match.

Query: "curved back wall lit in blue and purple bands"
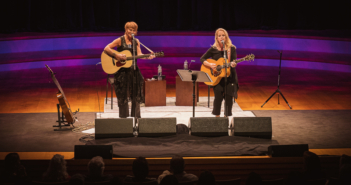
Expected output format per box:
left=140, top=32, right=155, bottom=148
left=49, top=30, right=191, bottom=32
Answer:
left=0, top=34, right=351, bottom=73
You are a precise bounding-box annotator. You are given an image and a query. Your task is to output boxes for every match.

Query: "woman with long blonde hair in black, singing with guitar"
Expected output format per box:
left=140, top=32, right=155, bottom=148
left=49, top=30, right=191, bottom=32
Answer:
left=200, top=28, right=239, bottom=117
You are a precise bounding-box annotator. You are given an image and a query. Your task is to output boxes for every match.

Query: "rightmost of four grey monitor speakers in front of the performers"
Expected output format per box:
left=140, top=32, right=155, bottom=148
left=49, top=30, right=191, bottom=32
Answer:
left=233, top=117, right=272, bottom=139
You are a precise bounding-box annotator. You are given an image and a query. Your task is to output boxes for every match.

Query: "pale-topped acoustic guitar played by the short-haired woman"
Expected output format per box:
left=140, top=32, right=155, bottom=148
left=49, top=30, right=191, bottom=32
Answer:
left=101, top=49, right=164, bottom=74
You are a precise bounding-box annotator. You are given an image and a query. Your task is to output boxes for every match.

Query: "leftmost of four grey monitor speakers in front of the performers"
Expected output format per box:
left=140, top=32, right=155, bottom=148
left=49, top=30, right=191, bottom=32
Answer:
left=95, top=118, right=134, bottom=139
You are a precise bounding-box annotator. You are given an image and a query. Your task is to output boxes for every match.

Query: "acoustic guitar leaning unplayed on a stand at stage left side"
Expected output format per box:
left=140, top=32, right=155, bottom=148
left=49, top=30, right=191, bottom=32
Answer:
left=45, top=65, right=76, bottom=125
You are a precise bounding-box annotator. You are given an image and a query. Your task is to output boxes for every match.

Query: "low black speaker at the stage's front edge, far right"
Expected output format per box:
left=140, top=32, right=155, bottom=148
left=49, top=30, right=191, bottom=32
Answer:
left=268, top=144, right=308, bottom=157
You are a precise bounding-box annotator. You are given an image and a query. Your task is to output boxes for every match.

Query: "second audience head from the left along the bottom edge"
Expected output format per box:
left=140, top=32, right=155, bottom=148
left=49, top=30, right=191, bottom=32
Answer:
left=43, top=154, right=68, bottom=182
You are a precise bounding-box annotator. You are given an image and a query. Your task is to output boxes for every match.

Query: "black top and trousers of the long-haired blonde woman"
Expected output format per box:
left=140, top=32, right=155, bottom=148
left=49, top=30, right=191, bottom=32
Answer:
left=200, top=46, right=239, bottom=116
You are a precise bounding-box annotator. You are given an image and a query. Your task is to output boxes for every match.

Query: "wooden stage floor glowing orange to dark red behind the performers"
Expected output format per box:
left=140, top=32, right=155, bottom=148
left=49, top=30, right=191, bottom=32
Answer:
left=0, top=63, right=351, bottom=113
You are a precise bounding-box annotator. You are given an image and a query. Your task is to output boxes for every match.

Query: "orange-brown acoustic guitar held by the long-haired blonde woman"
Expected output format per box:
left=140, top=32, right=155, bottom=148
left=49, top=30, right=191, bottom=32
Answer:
left=201, top=54, right=255, bottom=86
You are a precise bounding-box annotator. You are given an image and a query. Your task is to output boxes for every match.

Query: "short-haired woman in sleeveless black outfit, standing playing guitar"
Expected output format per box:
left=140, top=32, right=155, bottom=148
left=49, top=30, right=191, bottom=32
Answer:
left=104, top=22, right=155, bottom=118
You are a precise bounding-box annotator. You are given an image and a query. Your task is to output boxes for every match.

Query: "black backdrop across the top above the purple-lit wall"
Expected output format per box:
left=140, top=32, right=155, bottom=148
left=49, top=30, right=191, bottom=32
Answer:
left=0, top=0, right=351, bottom=33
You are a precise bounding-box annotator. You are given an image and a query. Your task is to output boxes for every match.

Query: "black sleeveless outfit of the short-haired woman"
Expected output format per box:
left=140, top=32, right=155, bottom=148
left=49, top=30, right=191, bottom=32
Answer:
left=114, top=36, right=144, bottom=118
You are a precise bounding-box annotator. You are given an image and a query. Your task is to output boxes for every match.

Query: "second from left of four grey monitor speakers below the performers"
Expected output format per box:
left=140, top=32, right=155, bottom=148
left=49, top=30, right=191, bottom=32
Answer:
left=138, top=118, right=177, bottom=137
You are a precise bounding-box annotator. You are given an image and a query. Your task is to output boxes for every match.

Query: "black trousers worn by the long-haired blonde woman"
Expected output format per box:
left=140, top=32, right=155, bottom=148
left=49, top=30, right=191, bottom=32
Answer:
left=212, top=83, right=233, bottom=116
